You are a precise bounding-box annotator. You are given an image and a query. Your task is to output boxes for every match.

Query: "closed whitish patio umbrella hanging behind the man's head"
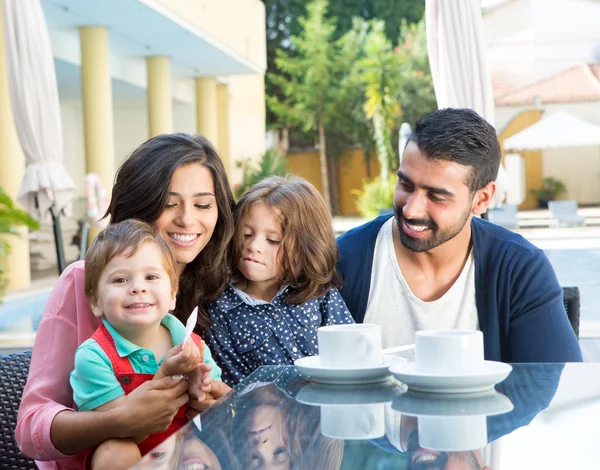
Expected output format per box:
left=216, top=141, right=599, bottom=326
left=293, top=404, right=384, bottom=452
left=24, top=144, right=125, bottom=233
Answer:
left=425, top=0, right=508, bottom=207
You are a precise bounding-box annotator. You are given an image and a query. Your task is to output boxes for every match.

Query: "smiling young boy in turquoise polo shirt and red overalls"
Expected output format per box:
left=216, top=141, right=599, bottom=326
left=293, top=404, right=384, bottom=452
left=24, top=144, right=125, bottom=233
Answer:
left=71, top=220, right=221, bottom=469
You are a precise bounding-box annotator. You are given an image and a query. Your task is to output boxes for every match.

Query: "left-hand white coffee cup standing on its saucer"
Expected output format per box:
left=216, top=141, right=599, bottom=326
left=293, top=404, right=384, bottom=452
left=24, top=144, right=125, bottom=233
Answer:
left=317, top=323, right=383, bottom=368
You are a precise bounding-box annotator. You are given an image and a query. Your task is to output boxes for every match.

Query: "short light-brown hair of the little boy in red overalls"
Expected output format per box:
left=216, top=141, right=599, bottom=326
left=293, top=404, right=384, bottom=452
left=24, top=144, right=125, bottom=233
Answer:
left=85, top=219, right=179, bottom=305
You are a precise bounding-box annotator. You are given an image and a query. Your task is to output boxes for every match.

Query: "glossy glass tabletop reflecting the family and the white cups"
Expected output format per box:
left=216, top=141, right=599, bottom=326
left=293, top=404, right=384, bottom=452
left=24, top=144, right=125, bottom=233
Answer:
left=135, top=363, right=600, bottom=470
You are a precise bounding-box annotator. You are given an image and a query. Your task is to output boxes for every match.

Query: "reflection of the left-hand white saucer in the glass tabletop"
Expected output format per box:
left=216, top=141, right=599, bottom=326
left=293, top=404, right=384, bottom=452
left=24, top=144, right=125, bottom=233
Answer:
left=296, top=380, right=404, bottom=406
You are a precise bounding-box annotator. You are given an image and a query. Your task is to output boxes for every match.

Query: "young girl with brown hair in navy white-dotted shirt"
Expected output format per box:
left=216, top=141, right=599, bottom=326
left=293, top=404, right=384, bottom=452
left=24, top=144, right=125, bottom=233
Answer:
left=205, top=177, right=353, bottom=385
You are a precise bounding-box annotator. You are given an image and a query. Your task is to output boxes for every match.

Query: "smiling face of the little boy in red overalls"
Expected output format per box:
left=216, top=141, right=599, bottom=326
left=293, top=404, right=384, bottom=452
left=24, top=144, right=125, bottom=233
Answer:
left=92, top=242, right=175, bottom=334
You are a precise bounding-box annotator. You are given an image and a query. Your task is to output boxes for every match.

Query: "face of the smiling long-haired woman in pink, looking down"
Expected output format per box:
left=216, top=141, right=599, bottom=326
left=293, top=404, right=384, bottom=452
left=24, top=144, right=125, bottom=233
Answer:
left=154, top=163, right=219, bottom=275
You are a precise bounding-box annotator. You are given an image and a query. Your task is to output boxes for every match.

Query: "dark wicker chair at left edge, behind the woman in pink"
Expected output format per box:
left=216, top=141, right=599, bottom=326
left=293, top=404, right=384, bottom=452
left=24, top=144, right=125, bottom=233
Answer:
left=0, top=351, right=37, bottom=470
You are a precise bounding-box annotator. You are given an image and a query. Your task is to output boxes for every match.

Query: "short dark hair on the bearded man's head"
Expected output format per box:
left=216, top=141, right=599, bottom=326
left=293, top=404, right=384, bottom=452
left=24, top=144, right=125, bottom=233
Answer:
left=407, top=108, right=502, bottom=193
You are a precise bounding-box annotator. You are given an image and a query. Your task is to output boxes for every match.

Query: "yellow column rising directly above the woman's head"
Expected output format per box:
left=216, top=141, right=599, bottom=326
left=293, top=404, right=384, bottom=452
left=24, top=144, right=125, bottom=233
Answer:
left=146, top=56, right=173, bottom=137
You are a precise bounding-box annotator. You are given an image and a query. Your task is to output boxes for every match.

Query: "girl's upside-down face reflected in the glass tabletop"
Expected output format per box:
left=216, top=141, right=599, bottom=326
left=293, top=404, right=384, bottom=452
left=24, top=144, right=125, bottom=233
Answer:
left=246, top=405, right=291, bottom=470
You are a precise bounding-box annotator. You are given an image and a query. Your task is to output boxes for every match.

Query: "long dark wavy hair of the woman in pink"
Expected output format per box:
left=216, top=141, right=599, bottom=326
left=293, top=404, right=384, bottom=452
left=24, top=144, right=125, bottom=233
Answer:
left=105, top=133, right=234, bottom=332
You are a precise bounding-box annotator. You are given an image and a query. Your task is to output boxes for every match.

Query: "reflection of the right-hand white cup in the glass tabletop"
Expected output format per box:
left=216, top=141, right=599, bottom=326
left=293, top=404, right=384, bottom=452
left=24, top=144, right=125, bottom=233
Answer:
left=417, top=415, right=487, bottom=452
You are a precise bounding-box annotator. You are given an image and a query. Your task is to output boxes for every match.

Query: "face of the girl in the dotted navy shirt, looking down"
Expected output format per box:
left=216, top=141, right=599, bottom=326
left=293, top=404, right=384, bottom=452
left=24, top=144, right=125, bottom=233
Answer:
left=238, top=203, right=283, bottom=290
